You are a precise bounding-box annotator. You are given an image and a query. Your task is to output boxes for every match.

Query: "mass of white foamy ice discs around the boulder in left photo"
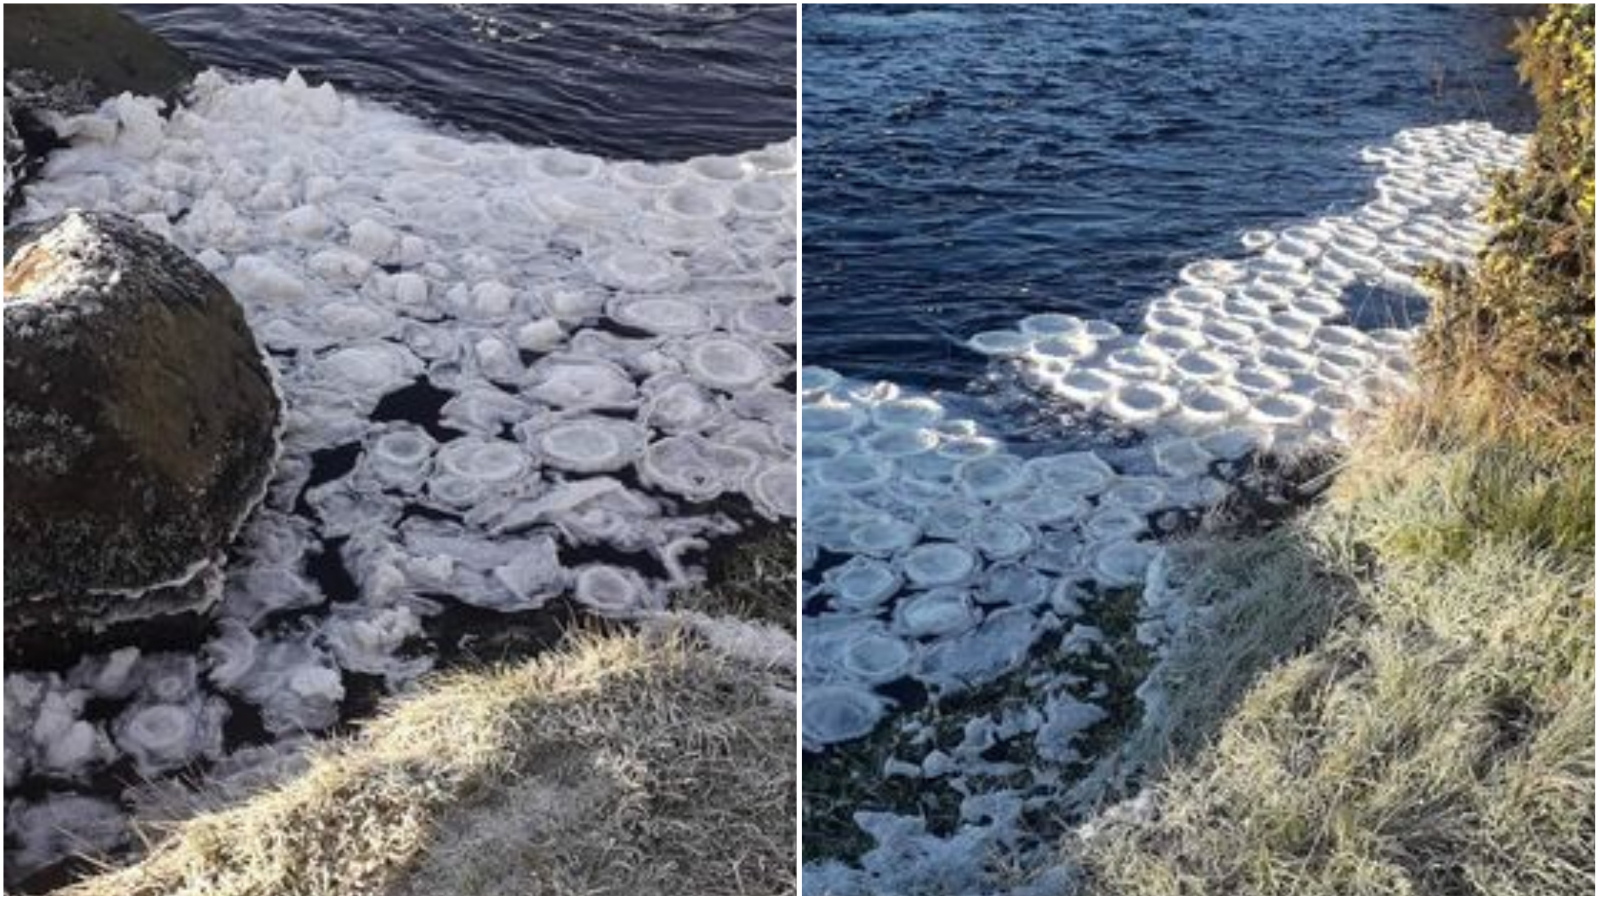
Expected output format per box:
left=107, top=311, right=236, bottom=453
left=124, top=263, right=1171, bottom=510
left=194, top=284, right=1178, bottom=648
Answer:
left=5, top=72, right=798, bottom=883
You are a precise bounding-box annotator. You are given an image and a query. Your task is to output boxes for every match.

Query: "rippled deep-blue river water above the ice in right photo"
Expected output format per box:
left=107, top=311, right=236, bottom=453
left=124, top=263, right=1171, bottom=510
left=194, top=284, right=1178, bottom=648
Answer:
left=802, top=6, right=1533, bottom=387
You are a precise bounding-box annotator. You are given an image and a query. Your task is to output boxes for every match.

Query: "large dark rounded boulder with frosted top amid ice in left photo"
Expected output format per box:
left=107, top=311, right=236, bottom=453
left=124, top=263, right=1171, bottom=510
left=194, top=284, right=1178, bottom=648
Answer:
left=5, top=213, right=282, bottom=643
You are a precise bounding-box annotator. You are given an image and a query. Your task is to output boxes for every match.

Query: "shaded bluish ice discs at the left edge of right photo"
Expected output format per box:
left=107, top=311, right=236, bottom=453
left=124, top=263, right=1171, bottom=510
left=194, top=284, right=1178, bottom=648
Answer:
left=800, top=377, right=1222, bottom=749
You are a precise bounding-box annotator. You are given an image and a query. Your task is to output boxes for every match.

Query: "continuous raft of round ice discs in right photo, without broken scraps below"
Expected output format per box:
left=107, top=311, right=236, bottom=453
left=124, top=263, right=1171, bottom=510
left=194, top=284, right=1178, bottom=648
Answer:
left=798, top=123, right=1522, bottom=742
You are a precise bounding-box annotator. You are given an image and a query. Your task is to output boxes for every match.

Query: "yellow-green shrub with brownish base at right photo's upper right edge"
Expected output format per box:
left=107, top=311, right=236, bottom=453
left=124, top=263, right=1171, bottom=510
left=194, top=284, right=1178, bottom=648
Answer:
left=1422, top=5, right=1595, bottom=429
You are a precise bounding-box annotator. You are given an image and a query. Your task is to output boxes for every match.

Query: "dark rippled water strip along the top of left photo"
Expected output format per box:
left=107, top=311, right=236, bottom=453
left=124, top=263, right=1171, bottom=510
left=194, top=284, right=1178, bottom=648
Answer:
left=123, top=3, right=797, bottom=160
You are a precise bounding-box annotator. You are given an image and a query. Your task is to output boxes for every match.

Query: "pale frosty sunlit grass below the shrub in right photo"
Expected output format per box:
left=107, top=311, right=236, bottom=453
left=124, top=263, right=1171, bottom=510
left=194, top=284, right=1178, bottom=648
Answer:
left=1067, top=395, right=1595, bottom=895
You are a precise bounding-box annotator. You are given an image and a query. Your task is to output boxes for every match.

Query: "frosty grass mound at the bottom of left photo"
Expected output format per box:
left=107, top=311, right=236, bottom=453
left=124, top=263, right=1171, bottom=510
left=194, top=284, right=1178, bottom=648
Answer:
left=70, top=634, right=795, bottom=895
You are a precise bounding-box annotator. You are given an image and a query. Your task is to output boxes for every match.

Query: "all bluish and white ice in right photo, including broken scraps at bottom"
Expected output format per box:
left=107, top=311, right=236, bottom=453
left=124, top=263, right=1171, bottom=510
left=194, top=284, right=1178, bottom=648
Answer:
left=800, top=123, right=1525, bottom=895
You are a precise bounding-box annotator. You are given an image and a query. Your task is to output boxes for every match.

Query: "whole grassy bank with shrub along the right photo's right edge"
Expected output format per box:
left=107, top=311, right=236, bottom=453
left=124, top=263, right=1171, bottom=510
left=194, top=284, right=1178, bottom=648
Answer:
left=1067, top=6, right=1595, bottom=895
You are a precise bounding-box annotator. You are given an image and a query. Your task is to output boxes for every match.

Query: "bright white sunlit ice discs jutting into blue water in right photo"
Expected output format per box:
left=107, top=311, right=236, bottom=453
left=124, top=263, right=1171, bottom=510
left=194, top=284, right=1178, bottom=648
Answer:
left=968, top=123, right=1523, bottom=456
